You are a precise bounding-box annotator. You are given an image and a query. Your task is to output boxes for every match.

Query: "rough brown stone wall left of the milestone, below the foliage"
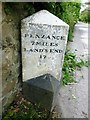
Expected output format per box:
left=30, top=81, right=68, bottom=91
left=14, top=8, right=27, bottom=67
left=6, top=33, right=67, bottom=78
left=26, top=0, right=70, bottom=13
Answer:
left=2, top=5, right=20, bottom=110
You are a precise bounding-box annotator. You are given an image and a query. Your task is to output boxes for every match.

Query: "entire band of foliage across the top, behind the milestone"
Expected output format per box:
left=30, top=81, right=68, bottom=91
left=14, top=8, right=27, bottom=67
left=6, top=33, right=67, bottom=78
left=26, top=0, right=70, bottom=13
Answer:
left=4, top=2, right=80, bottom=41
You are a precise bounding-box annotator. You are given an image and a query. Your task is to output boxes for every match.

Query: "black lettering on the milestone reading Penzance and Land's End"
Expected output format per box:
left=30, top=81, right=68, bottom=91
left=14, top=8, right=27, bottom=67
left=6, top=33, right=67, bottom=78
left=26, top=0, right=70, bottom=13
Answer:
left=24, top=33, right=66, bottom=59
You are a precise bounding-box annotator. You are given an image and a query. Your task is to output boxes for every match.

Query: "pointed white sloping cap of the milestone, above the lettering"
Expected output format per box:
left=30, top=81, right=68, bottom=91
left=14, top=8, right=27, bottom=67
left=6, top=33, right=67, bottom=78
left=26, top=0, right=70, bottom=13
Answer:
left=22, top=10, right=69, bottom=27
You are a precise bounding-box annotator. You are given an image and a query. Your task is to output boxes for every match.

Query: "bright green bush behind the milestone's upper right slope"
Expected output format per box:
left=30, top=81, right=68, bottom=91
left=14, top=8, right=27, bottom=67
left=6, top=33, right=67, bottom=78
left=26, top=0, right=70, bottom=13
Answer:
left=44, top=2, right=81, bottom=41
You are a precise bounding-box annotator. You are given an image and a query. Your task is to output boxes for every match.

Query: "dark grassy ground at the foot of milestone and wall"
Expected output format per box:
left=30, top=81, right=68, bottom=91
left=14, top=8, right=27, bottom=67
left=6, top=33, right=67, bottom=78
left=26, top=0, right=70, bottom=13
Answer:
left=2, top=94, right=49, bottom=120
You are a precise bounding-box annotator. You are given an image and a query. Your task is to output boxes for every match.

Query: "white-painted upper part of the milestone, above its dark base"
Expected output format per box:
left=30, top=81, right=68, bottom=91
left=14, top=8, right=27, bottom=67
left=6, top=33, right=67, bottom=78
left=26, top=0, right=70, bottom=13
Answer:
left=21, top=10, right=69, bottom=81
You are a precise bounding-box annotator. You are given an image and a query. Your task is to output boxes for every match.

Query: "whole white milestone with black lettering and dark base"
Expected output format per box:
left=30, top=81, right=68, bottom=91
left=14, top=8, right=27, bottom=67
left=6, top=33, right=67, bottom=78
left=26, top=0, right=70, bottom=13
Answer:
left=21, top=10, right=69, bottom=110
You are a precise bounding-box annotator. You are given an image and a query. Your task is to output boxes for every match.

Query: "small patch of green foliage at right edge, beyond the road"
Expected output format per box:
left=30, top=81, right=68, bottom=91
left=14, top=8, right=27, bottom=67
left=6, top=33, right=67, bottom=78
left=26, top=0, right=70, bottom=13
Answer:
left=80, top=10, right=90, bottom=23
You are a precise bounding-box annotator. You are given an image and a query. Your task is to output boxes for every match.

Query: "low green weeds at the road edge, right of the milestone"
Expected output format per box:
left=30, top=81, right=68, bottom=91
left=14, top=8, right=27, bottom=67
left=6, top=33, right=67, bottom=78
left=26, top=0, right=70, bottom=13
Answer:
left=62, top=50, right=90, bottom=85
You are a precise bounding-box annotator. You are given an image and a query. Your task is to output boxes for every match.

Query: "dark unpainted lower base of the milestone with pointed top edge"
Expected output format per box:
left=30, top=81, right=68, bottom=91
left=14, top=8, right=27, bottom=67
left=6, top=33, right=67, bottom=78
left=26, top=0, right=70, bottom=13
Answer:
left=23, top=74, right=60, bottom=110
